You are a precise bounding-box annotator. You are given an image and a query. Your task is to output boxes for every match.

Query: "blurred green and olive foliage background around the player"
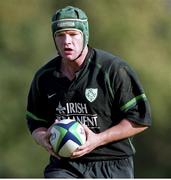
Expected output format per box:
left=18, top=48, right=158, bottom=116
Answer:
left=0, top=0, right=171, bottom=178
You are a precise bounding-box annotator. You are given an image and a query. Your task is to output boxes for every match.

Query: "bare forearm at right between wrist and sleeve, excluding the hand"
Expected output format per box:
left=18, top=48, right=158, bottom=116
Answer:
left=98, top=119, right=147, bottom=146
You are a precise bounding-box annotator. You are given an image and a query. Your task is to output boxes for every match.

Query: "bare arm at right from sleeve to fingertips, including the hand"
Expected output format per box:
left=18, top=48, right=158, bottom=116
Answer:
left=72, top=119, right=147, bottom=158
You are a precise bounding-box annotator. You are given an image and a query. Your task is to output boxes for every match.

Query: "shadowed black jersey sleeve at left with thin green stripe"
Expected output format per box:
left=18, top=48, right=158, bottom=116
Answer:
left=26, top=77, right=49, bottom=133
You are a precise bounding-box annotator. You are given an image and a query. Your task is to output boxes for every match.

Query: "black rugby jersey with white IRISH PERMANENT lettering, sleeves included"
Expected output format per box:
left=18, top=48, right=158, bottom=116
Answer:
left=26, top=48, right=151, bottom=160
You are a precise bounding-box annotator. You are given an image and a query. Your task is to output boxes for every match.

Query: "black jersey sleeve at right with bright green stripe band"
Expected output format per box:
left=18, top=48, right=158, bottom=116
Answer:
left=114, top=65, right=151, bottom=126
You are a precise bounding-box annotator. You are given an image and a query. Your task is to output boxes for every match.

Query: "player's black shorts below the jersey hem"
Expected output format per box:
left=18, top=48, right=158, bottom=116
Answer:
left=44, top=157, right=134, bottom=178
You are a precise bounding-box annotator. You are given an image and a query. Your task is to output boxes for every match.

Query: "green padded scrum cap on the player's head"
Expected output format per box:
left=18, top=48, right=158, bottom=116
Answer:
left=52, top=6, right=89, bottom=47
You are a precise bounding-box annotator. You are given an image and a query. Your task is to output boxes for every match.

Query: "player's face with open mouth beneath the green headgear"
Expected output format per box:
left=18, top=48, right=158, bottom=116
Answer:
left=55, top=30, right=83, bottom=60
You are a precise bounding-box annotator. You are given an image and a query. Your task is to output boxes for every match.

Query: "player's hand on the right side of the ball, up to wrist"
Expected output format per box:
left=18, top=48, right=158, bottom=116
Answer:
left=71, top=125, right=100, bottom=159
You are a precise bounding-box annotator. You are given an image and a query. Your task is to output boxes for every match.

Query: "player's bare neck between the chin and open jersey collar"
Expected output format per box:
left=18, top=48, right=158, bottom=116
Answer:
left=61, top=46, right=88, bottom=80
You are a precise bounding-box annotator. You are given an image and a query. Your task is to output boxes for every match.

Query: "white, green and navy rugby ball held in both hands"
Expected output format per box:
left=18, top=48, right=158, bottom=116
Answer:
left=50, top=119, right=86, bottom=157
